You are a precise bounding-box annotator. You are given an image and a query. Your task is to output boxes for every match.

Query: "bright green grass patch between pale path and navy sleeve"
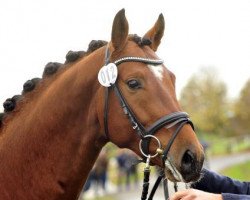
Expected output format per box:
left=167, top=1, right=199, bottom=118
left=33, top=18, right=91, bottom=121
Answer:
left=220, top=161, right=250, bottom=181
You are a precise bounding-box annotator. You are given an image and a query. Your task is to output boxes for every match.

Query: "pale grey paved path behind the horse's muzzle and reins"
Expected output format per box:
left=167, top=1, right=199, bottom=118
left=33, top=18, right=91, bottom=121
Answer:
left=84, top=152, right=250, bottom=200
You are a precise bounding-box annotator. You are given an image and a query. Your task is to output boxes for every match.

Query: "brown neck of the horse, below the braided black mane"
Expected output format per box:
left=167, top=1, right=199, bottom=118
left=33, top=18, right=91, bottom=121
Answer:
left=0, top=49, right=106, bottom=200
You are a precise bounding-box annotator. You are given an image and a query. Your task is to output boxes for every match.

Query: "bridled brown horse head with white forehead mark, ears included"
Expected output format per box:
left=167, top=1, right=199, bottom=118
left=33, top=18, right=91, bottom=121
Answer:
left=97, top=9, right=204, bottom=182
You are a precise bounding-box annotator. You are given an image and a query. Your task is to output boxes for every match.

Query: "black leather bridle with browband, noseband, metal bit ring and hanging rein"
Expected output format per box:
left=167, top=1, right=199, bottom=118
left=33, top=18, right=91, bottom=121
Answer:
left=98, top=47, right=194, bottom=199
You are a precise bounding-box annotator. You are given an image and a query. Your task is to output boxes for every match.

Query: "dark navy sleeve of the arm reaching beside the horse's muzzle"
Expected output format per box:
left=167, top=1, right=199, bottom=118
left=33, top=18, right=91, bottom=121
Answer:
left=192, top=169, right=250, bottom=195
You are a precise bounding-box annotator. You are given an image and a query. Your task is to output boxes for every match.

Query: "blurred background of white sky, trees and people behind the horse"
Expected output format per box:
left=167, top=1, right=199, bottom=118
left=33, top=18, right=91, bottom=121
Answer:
left=0, top=0, right=250, bottom=200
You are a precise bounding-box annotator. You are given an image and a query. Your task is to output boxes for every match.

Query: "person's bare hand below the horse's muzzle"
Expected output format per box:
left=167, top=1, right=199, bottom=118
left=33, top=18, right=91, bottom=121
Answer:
left=169, top=189, right=222, bottom=200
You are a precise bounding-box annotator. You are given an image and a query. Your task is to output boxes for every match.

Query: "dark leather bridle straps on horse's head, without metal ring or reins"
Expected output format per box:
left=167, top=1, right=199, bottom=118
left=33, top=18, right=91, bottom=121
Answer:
left=100, top=47, right=194, bottom=160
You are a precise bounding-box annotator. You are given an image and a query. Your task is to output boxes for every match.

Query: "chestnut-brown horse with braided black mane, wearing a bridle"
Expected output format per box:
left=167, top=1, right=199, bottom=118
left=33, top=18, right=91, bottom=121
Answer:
left=0, top=9, right=204, bottom=200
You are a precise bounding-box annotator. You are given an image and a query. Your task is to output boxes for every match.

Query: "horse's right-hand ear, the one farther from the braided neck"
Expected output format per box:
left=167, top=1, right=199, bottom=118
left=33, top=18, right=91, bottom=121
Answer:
left=143, top=14, right=165, bottom=51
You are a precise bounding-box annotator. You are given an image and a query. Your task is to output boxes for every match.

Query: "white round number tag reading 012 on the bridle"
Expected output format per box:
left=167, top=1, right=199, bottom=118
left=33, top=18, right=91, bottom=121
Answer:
left=98, top=63, right=118, bottom=87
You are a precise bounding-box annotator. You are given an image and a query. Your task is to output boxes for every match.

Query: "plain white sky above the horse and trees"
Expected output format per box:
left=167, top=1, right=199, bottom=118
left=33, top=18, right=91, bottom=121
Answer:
left=0, top=0, right=250, bottom=111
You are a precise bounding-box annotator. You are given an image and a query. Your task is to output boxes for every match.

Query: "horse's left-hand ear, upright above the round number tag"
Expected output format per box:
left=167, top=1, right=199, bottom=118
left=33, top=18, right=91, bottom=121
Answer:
left=111, top=9, right=128, bottom=51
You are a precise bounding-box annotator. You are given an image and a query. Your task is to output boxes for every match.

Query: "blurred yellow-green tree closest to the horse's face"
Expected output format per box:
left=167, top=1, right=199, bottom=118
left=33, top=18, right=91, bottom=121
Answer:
left=180, top=68, right=227, bottom=133
